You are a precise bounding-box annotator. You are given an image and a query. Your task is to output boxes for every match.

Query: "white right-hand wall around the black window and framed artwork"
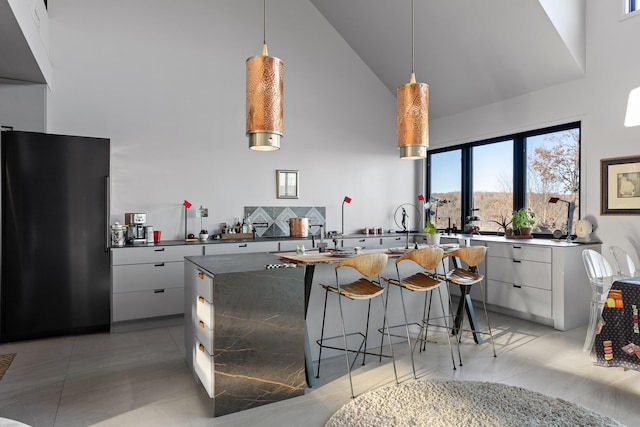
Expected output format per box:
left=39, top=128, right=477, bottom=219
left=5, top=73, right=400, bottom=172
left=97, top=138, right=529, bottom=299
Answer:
left=431, top=1, right=640, bottom=259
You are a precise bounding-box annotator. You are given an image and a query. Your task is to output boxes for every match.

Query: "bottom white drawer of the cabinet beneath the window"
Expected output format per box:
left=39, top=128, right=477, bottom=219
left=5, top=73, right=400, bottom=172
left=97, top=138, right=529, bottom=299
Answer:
left=487, top=280, right=552, bottom=319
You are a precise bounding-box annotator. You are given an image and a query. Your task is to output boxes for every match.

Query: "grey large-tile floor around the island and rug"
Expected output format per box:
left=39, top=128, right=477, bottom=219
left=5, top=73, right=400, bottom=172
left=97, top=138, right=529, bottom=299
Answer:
left=0, top=314, right=640, bottom=427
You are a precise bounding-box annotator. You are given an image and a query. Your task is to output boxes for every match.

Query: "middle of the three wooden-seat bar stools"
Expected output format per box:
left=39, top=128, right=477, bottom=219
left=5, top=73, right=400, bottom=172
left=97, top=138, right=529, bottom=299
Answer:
left=381, top=247, right=460, bottom=378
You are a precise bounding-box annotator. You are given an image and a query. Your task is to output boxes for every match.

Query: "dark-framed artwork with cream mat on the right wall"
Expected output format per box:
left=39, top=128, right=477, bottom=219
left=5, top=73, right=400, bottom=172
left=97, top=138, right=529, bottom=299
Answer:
left=600, top=156, right=640, bottom=215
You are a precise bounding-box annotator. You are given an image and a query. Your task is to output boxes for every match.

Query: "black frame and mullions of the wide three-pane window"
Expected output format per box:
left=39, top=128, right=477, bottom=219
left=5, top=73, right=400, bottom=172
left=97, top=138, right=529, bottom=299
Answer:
left=425, top=121, right=582, bottom=238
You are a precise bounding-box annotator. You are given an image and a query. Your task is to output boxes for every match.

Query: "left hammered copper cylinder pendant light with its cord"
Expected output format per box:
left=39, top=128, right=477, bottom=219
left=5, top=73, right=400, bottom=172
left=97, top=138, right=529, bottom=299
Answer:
left=247, top=0, right=284, bottom=151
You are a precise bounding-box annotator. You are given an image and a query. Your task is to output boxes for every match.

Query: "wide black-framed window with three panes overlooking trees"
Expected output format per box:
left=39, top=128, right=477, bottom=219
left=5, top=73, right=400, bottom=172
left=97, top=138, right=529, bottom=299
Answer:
left=427, top=123, right=580, bottom=235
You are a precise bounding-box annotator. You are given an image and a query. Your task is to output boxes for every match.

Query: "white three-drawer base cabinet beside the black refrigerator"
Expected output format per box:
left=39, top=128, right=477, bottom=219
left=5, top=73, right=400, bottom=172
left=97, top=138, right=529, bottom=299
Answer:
left=111, top=245, right=204, bottom=323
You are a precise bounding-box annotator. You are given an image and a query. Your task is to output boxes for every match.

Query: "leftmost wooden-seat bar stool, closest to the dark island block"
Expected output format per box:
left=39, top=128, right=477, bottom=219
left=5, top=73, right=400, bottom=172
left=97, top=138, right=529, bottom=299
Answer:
left=316, top=253, right=398, bottom=398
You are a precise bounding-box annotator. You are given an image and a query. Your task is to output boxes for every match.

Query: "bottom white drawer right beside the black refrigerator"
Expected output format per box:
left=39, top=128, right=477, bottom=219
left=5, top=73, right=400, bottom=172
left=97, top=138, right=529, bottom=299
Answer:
left=111, top=288, right=184, bottom=322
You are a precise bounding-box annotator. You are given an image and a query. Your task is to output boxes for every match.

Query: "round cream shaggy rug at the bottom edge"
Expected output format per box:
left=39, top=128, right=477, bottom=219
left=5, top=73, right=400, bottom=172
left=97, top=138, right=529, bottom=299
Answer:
left=325, top=380, right=623, bottom=427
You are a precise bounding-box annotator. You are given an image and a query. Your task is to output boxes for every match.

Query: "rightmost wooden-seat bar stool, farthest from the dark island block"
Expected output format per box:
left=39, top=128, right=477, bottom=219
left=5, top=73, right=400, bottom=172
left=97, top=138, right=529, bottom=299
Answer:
left=443, top=246, right=497, bottom=365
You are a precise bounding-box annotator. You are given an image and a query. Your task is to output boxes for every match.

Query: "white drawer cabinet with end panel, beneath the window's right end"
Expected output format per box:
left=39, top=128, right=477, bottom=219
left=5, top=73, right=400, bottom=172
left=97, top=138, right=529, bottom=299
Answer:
left=486, top=241, right=600, bottom=331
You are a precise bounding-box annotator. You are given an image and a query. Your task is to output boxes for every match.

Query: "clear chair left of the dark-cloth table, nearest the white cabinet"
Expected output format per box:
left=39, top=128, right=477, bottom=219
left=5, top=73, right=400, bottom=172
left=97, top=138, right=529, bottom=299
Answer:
left=582, top=249, right=614, bottom=351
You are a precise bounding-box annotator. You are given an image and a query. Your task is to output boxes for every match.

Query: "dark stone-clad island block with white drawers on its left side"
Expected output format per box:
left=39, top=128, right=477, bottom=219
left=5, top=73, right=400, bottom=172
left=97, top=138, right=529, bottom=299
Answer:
left=184, top=253, right=306, bottom=416
